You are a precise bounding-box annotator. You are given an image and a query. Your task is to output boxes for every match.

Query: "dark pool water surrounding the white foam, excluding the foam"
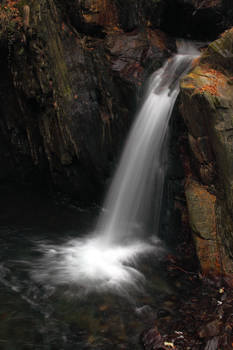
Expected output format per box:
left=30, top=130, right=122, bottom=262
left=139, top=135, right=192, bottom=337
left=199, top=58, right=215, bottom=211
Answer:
left=0, top=190, right=175, bottom=350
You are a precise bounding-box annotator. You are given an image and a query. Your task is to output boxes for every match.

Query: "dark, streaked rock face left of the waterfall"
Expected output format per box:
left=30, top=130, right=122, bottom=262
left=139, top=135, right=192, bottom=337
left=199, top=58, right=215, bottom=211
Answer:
left=0, top=0, right=170, bottom=200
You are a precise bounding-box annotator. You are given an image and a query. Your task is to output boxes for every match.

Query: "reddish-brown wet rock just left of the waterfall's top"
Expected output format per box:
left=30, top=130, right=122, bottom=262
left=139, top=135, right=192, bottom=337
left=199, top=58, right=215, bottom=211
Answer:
left=106, top=29, right=174, bottom=80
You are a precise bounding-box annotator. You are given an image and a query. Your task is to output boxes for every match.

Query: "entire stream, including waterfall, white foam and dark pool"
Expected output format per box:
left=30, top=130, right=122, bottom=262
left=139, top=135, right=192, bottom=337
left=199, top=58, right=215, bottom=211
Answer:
left=0, top=42, right=198, bottom=350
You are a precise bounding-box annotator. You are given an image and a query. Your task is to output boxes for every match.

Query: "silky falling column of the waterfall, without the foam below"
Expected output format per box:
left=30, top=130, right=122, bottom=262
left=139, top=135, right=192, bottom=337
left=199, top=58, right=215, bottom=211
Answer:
left=97, top=44, right=198, bottom=244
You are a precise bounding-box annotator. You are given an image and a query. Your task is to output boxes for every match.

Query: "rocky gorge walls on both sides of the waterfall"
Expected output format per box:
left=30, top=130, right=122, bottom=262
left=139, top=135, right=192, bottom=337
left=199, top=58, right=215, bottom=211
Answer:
left=0, top=0, right=233, bottom=283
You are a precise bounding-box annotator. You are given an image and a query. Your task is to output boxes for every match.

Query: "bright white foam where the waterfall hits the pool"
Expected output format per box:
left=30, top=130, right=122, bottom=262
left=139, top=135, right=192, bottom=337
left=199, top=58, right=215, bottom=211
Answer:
left=33, top=236, right=159, bottom=294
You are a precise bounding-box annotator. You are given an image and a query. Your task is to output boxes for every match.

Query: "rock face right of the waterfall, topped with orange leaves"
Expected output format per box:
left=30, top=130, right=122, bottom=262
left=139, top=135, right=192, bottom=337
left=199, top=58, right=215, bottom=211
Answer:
left=181, top=29, right=233, bottom=284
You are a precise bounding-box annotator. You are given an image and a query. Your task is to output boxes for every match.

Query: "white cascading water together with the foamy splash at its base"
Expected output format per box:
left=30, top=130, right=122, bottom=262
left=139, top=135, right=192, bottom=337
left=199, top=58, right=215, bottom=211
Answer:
left=33, top=42, right=199, bottom=294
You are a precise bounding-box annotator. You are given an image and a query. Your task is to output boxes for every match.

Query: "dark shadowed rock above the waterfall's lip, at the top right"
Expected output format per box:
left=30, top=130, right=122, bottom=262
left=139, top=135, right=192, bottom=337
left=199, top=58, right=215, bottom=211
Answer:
left=114, top=0, right=233, bottom=40
